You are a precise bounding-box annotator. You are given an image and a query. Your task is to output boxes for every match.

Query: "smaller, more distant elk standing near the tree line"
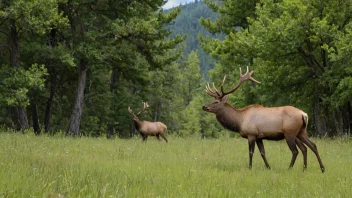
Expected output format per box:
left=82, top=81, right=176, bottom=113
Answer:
left=128, top=102, right=168, bottom=143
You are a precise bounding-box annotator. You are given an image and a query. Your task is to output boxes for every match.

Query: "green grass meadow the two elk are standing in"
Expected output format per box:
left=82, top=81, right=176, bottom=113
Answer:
left=0, top=133, right=352, bottom=197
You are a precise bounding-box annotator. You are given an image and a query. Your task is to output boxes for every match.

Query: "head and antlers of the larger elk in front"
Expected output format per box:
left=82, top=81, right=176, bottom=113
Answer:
left=203, top=67, right=260, bottom=114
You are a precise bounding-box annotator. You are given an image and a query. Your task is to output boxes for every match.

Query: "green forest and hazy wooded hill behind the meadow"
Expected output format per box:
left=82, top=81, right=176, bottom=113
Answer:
left=0, top=0, right=352, bottom=137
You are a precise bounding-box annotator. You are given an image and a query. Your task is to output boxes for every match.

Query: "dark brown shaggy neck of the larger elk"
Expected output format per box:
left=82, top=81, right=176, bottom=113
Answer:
left=216, top=104, right=242, bottom=132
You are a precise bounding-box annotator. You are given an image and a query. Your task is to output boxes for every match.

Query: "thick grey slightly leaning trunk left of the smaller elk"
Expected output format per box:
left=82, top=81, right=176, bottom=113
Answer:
left=67, top=60, right=88, bottom=136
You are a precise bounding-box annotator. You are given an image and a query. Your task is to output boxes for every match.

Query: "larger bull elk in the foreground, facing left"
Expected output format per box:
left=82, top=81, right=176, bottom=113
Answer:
left=203, top=67, right=325, bottom=172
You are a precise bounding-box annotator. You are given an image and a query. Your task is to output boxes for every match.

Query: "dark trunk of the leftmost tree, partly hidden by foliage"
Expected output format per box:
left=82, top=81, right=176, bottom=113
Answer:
left=9, top=19, right=29, bottom=130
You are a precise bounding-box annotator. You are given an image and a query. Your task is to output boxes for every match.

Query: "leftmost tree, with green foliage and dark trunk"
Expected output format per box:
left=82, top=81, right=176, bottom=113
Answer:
left=0, top=0, right=66, bottom=133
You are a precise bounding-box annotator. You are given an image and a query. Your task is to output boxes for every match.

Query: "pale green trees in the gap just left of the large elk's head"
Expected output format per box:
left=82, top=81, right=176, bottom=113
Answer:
left=177, top=51, right=220, bottom=138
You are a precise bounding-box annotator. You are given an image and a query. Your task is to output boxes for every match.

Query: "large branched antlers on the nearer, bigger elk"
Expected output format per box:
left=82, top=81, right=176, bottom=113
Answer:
left=205, top=67, right=260, bottom=98
